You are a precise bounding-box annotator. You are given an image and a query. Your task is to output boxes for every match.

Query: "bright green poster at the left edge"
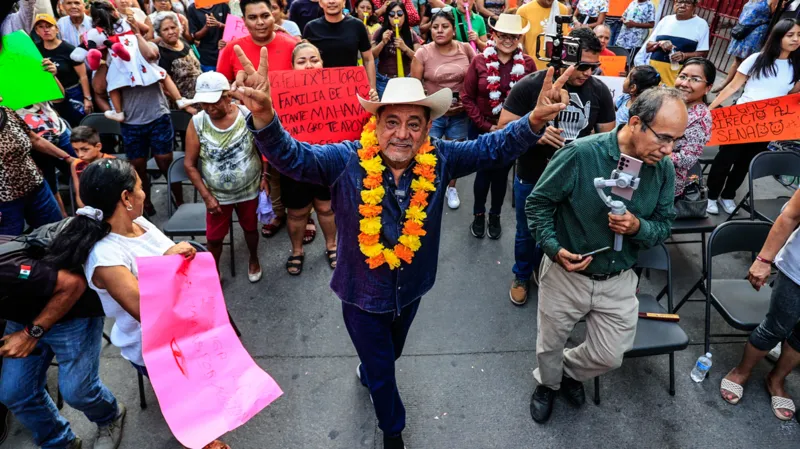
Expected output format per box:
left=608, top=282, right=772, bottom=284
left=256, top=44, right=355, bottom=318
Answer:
left=0, top=30, right=64, bottom=109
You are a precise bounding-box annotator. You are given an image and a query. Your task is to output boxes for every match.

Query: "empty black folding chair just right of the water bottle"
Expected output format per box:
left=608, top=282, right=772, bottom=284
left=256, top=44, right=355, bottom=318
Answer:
left=704, top=220, right=772, bottom=352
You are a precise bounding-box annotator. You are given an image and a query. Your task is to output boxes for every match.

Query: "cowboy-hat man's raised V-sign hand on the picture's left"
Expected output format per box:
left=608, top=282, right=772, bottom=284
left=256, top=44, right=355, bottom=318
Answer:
left=231, top=45, right=275, bottom=129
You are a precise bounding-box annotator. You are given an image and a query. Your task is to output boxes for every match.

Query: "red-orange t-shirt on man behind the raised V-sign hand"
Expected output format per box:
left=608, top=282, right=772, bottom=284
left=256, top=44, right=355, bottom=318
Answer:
left=217, top=32, right=297, bottom=81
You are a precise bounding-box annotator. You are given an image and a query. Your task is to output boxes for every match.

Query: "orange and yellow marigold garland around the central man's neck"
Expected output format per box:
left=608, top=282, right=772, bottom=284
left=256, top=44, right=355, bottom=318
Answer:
left=358, top=117, right=437, bottom=270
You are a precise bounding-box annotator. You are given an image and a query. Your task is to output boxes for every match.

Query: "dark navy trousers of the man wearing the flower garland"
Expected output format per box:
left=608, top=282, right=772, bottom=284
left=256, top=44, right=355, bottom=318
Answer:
left=342, top=299, right=420, bottom=436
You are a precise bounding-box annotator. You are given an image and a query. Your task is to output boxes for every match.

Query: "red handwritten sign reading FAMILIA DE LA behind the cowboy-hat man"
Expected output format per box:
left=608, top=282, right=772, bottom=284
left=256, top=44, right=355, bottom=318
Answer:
left=269, top=67, right=369, bottom=144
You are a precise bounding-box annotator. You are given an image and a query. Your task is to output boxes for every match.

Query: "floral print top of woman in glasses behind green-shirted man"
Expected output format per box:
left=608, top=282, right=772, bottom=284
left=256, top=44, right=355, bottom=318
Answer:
left=670, top=103, right=712, bottom=196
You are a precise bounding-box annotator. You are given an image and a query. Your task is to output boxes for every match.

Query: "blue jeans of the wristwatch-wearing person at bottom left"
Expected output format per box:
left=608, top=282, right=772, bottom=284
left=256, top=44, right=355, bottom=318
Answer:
left=0, top=317, right=118, bottom=449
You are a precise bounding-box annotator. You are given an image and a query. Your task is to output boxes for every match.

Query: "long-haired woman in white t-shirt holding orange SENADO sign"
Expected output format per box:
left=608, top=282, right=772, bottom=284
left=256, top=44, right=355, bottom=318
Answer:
left=708, top=19, right=800, bottom=214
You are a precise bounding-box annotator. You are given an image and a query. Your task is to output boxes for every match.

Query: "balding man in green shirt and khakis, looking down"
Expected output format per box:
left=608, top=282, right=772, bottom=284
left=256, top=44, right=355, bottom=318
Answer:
left=518, top=88, right=688, bottom=423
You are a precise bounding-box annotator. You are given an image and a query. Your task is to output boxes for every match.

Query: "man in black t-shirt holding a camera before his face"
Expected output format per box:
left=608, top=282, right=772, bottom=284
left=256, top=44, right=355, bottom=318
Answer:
left=498, top=25, right=616, bottom=305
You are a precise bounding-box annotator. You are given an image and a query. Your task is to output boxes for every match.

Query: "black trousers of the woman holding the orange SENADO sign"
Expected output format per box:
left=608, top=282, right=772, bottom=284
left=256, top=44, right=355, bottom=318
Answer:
left=708, top=142, right=769, bottom=200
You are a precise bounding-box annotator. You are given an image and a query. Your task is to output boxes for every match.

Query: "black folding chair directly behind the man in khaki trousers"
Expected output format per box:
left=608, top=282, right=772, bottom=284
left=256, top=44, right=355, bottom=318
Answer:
left=594, top=244, right=689, bottom=404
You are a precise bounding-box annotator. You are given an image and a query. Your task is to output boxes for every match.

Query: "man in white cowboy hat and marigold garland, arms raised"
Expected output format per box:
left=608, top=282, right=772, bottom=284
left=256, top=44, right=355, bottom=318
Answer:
left=232, top=48, right=571, bottom=449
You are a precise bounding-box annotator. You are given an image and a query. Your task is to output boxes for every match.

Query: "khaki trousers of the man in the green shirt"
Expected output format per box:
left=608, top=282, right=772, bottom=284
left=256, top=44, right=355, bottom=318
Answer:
left=533, top=257, right=639, bottom=390
